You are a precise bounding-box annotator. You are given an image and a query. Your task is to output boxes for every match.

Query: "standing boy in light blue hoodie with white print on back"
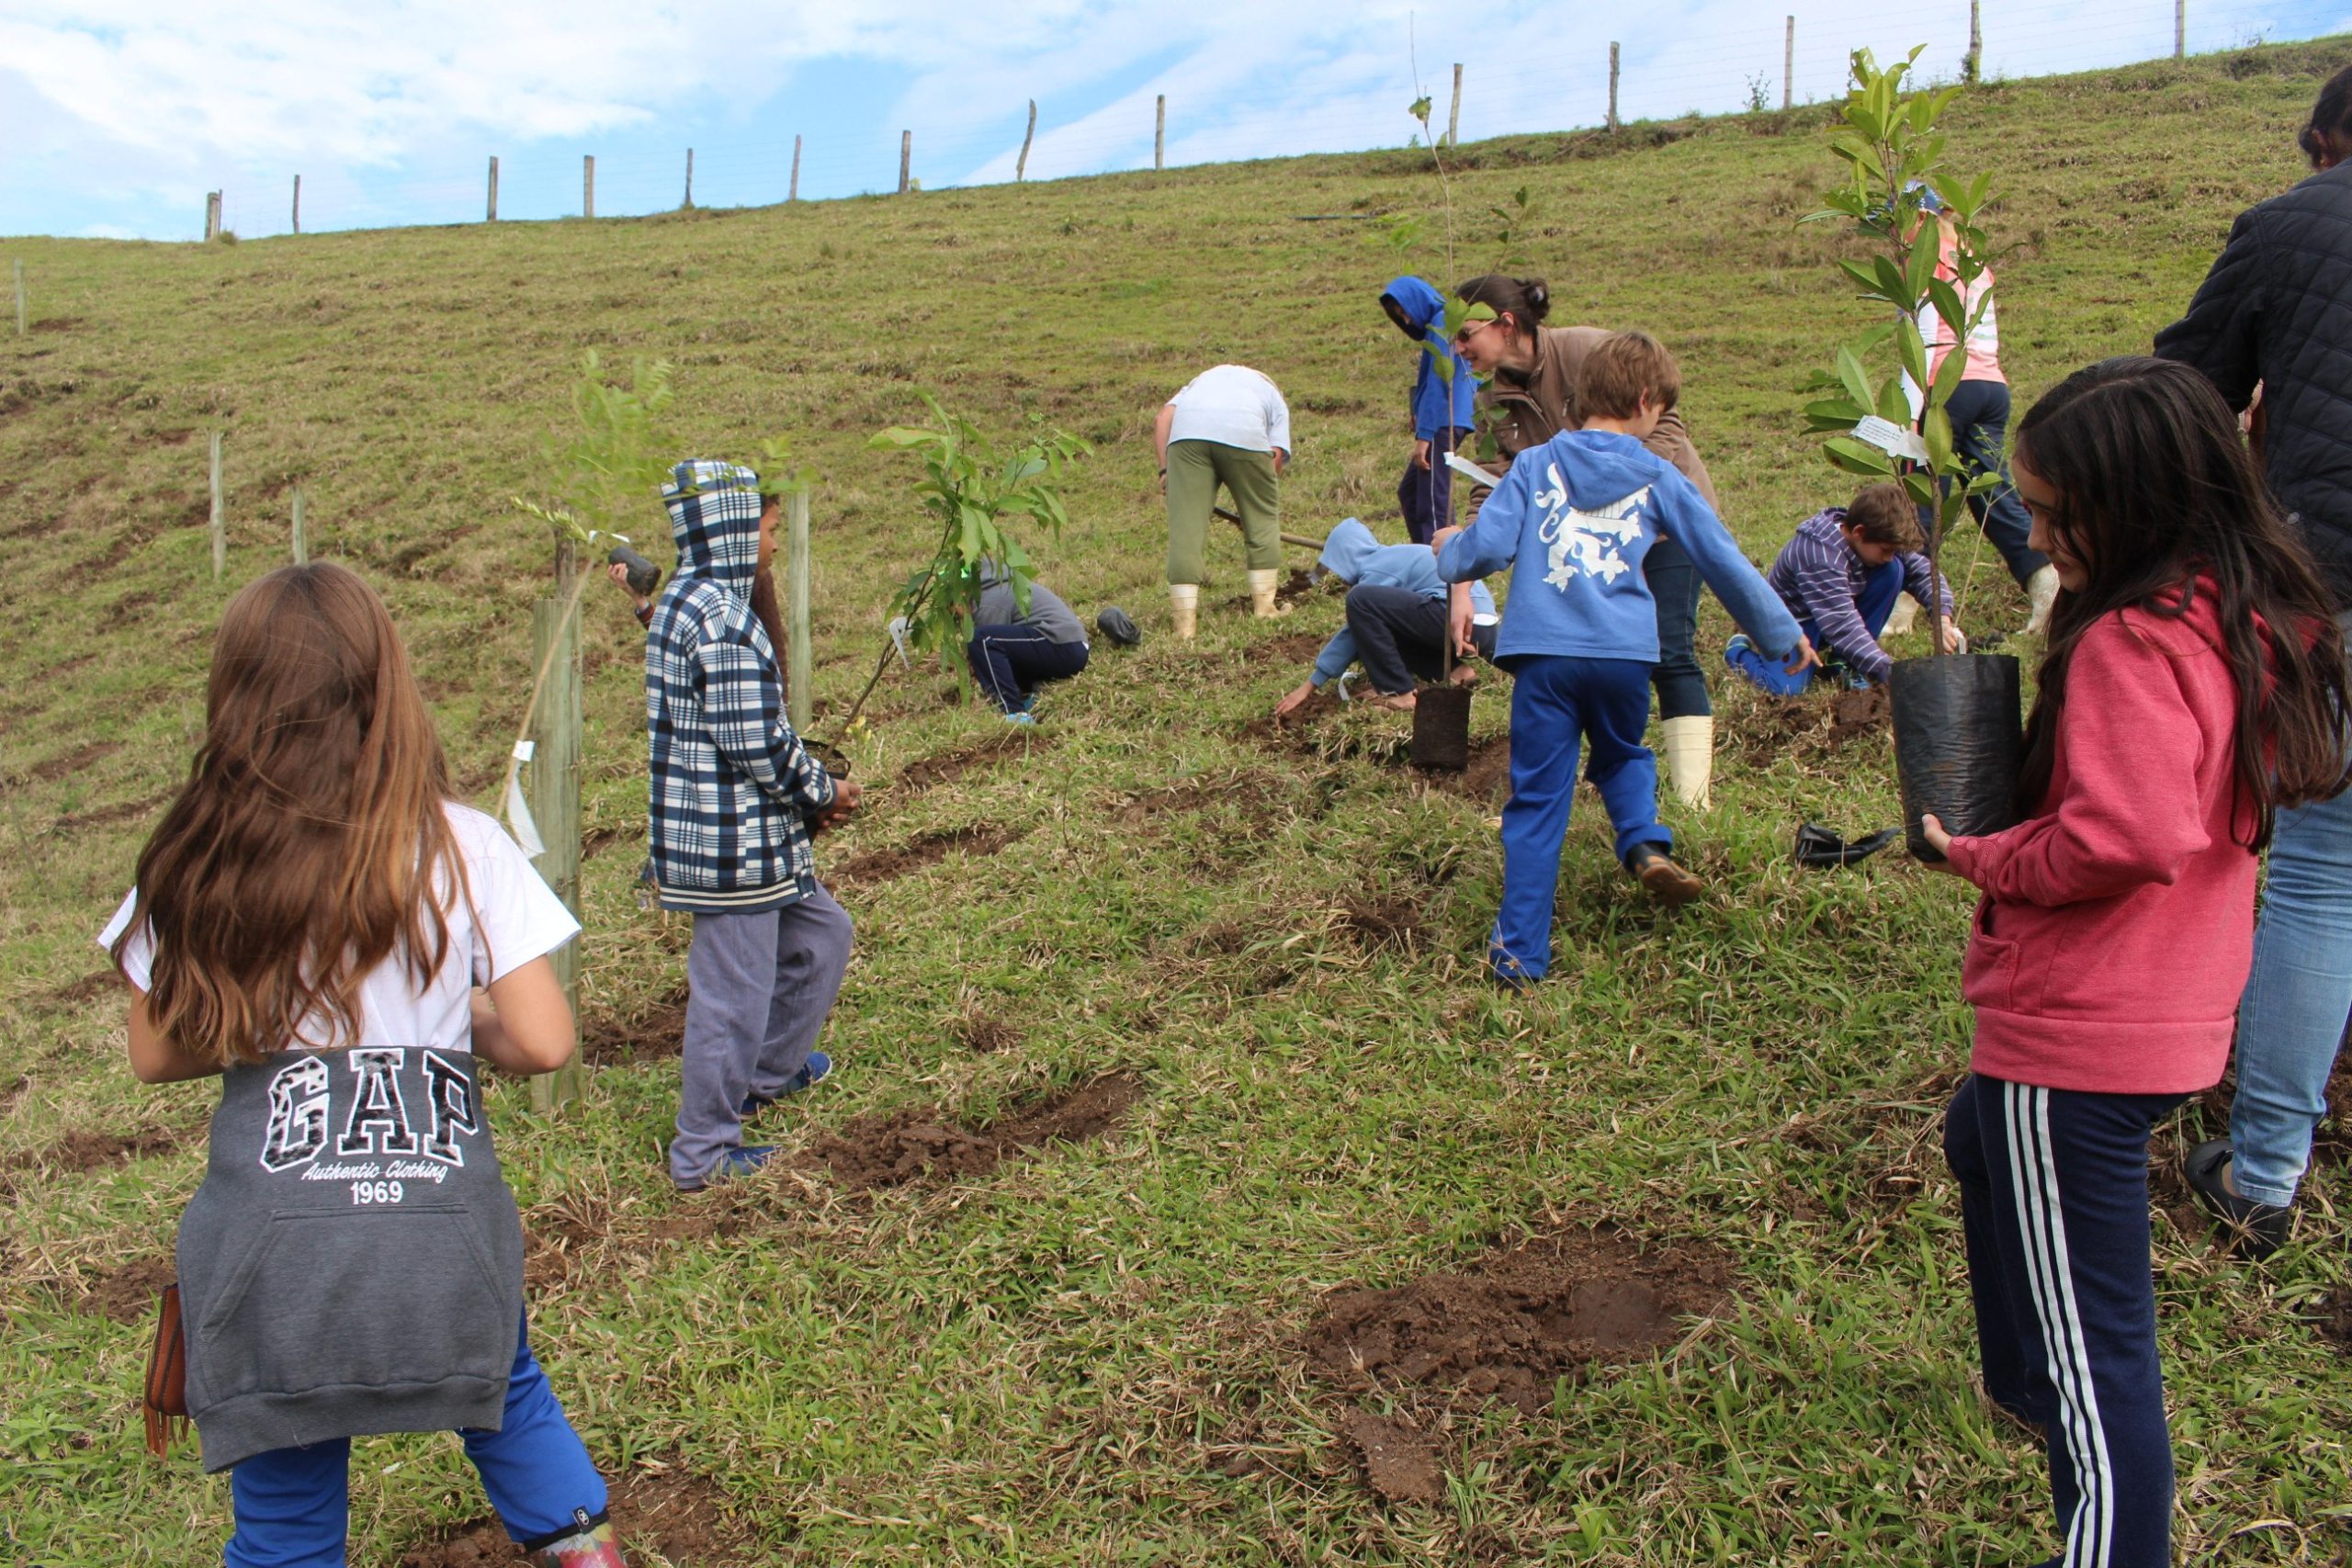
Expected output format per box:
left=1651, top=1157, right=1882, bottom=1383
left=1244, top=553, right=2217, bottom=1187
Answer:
left=1437, top=332, right=1815, bottom=987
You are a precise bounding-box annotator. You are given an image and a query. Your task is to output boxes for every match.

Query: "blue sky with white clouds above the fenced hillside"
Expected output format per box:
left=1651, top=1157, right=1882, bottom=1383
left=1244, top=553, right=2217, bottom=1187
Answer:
left=0, top=0, right=2352, bottom=240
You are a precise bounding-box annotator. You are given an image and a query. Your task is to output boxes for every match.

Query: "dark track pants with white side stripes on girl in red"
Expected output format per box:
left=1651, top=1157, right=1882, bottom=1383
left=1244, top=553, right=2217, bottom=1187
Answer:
left=1943, top=1075, right=2188, bottom=1568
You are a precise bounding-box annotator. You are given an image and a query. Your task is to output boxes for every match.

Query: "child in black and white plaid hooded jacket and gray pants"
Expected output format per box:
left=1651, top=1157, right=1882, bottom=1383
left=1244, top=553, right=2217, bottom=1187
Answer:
left=644, top=458, right=858, bottom=1192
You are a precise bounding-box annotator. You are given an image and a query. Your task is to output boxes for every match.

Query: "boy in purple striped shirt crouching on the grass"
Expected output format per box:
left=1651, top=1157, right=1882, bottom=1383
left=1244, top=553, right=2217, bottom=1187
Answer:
left=1724, top=482, right=1969, bottom=696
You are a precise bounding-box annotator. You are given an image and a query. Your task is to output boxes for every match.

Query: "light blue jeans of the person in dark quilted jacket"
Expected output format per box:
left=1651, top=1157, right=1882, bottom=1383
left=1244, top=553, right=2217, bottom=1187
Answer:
left=2230, top=747, right=2352, bottom=1208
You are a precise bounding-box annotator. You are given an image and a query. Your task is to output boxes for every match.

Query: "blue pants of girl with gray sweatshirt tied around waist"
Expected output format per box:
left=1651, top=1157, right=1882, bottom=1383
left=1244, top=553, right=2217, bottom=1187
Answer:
left=221, top=1321, right=605, bottom=1568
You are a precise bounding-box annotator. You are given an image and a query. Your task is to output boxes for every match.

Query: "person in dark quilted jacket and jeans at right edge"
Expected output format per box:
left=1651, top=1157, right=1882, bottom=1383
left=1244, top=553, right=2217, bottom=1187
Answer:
left=2157, top=68, right=2352, bottom=1258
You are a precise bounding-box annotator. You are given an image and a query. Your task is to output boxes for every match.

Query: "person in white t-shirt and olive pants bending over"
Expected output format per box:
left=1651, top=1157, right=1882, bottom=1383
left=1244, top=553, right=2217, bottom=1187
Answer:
left=1158, top=365, right=1291, bottom=637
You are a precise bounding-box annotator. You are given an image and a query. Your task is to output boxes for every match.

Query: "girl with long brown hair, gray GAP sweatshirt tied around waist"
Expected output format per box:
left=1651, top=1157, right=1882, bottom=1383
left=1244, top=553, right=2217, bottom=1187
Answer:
left=101, top=564, right=621, bottom=1568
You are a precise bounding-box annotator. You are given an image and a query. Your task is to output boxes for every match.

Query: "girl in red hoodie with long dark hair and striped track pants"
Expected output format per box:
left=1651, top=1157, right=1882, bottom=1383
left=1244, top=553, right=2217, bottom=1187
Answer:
left=1927, top=360, right=2345, bottom=1568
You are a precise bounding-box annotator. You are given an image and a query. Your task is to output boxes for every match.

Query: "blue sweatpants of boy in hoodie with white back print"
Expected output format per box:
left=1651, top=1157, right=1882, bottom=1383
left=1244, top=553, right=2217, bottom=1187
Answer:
left=1487, top=653, right=1675, bottom=980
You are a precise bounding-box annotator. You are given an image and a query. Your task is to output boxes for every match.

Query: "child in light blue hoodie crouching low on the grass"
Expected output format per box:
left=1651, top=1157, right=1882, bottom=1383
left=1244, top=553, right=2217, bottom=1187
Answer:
left=1275, top=517, right=1496, bottom=719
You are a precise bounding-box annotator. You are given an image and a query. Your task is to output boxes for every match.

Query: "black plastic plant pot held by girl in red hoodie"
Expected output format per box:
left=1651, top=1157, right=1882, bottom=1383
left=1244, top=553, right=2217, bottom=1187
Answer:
left=1886, top=653, right=2025, bottom=861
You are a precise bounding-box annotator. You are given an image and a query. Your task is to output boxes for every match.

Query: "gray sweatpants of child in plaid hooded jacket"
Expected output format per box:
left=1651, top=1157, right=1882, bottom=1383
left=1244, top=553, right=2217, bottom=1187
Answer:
left=671, top=886, right=849, bottom=1182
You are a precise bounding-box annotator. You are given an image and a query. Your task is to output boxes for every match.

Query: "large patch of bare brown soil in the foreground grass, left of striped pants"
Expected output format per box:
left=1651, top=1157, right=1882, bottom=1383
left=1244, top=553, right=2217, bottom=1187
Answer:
left=1303, top=1227, right=1731, bottom=1416
